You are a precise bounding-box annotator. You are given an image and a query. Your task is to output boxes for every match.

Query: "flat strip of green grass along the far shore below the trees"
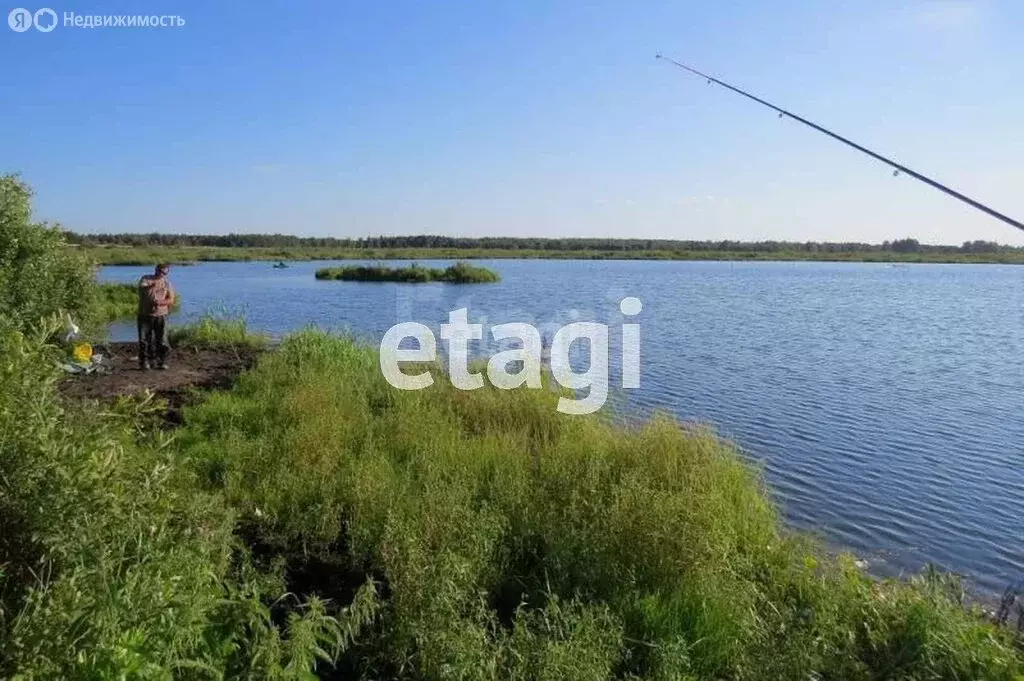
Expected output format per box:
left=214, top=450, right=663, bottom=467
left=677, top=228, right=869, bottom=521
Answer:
left=81, top=246, right=1024, bottom=265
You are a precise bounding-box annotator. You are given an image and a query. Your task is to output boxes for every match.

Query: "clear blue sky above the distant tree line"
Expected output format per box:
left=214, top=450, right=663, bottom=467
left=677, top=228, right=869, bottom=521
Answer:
left=0, top=0, right=1024, bottom=245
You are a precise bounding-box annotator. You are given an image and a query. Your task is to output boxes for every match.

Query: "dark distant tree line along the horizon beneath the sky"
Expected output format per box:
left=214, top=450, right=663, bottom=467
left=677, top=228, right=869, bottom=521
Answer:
left=68, top=232, right=1024, bottom=253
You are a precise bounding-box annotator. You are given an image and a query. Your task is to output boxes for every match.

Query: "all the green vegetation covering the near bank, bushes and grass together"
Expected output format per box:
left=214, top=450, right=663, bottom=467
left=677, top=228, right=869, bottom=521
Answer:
left=0, top=178, right=1024, bottom=681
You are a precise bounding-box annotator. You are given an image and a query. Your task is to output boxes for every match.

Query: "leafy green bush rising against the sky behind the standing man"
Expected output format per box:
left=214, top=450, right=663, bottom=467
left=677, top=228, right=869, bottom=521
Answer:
left=0, top=175, right=93, bottom=329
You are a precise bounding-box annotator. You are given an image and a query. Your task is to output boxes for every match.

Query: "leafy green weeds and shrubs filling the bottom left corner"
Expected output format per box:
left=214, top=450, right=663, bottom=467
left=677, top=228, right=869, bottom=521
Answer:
left=0, top=328, right=368, bottom=680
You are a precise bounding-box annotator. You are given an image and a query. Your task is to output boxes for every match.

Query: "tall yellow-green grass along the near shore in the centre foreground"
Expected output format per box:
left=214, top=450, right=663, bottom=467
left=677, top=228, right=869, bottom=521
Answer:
left=180, top=332, right=1024, bottom=681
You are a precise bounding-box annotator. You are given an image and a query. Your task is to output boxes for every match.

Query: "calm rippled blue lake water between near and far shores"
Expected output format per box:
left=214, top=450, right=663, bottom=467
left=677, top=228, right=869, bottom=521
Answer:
left=102, top=260, right=1024, bottom=592
